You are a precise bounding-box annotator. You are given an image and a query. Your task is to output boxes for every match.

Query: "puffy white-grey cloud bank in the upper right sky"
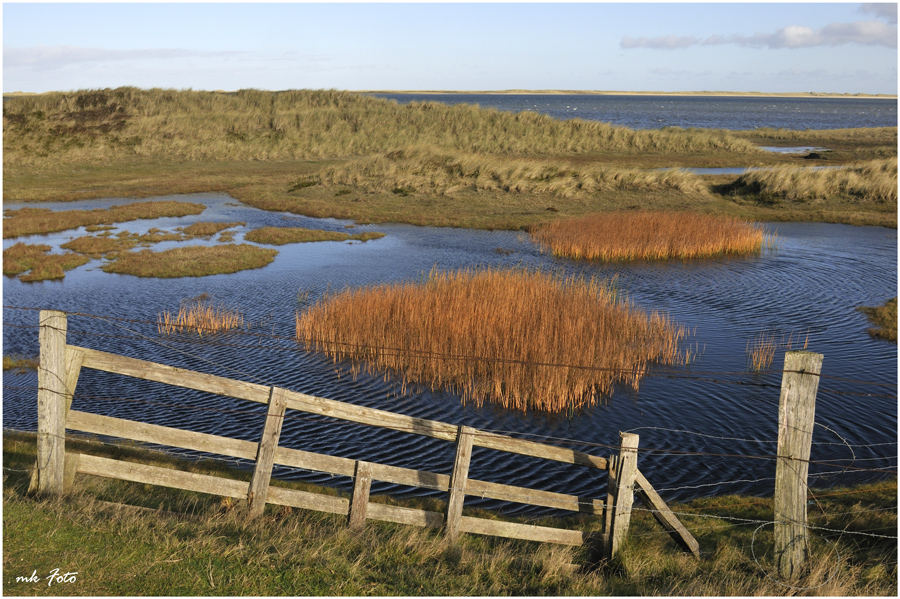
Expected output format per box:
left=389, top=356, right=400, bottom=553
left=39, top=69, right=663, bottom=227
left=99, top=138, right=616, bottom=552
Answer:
left=621, top=19, right=897, bottom=50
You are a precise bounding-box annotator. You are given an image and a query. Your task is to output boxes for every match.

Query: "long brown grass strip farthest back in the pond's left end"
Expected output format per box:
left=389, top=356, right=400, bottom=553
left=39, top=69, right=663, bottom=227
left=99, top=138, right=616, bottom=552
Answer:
left=3, top=200, right=206, bottom=239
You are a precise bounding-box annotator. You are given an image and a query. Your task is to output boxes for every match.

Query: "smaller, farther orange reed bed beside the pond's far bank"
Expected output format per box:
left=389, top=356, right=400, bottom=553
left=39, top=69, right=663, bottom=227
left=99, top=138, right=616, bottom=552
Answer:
left=531, top=212, right=767, bottom=261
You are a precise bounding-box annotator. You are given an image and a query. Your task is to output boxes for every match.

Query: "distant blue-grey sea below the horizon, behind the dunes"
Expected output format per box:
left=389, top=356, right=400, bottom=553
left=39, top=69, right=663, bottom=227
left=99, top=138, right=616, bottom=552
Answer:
left=373, top=94, right=897, bottom=130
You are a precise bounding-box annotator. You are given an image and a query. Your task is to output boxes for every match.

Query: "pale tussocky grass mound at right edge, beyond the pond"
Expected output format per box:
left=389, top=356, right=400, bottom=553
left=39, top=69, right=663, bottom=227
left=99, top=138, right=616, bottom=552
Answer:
left=734, top=157, right=897, bottom=205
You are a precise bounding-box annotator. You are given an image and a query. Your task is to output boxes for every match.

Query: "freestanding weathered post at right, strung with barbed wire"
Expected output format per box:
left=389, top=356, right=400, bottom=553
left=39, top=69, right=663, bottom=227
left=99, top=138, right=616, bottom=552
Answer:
left=775, top=351, right=823, bottom=579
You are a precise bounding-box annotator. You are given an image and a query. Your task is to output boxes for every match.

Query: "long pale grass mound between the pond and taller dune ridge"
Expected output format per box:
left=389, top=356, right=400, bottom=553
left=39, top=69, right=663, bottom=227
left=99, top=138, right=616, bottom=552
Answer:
left=316, top=146, right=708, bottom=198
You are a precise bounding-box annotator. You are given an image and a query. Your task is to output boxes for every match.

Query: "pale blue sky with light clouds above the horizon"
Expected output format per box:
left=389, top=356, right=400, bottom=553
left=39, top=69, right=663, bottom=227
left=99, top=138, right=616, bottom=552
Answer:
left=3, top=2, right=897, bottom=94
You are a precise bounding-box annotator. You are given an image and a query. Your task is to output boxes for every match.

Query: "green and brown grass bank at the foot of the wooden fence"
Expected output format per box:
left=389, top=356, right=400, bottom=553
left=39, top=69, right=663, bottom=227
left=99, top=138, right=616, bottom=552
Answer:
left=3, top=431, right=897, bottom=597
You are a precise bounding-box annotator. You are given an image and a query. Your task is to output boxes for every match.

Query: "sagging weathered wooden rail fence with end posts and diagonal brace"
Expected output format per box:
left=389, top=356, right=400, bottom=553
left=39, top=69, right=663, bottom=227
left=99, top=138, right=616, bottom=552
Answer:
left=32, top=311, right=699, bottom=557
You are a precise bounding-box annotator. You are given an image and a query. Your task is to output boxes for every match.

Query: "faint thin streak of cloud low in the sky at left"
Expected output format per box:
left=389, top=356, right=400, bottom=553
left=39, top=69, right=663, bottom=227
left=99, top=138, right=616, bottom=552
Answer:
left=3, top=46, right=240, bottom=70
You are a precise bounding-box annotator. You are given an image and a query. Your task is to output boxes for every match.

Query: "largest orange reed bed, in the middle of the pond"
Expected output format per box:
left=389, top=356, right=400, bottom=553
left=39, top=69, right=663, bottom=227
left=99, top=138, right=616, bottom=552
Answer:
left=296, top=270, right=690, bottom=412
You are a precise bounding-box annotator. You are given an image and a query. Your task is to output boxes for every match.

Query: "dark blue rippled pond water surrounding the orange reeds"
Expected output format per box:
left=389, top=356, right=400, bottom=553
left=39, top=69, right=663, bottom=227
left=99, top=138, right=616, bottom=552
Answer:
left=3, top=194, right=897, bottom=506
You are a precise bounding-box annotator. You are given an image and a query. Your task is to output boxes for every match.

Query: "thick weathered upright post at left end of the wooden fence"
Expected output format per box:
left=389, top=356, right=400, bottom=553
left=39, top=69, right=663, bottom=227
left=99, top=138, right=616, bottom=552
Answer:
left=32, top=310, right=68, bottom=495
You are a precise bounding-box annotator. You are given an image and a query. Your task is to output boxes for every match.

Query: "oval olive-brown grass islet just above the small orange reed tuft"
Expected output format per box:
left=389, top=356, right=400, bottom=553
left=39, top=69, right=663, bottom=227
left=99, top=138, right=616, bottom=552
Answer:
left=103, top=243, right=278, bottom=279
